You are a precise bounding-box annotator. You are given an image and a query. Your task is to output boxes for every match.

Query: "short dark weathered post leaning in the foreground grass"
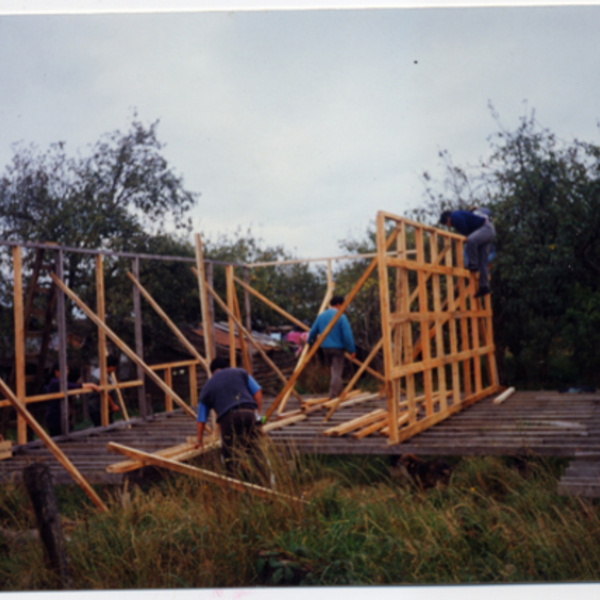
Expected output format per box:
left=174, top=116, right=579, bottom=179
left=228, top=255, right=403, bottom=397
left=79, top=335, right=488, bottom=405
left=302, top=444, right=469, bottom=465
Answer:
left=23, top=462, right=73, bottom=590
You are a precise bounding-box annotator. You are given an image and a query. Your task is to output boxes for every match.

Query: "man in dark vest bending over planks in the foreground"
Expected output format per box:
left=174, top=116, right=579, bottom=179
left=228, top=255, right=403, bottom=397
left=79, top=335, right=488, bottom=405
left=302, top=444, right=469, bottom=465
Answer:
left=196, top=358, right=262, bottom=472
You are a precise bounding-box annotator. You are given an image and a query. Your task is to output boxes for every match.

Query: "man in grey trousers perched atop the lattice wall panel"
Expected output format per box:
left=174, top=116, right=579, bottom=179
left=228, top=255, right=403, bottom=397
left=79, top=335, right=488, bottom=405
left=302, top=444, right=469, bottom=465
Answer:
left=440, top=210, right=496, bottom=298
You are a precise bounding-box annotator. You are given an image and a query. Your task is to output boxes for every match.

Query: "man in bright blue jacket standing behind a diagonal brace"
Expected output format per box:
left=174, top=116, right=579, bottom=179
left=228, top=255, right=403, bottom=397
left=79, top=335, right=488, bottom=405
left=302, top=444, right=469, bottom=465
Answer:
left=308, top=296, right=356, bottom=398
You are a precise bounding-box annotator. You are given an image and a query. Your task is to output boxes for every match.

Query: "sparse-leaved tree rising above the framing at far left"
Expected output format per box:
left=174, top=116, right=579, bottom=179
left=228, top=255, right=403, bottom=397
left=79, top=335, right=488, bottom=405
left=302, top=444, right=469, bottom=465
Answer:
left=0, top=115, right=198, bottom=286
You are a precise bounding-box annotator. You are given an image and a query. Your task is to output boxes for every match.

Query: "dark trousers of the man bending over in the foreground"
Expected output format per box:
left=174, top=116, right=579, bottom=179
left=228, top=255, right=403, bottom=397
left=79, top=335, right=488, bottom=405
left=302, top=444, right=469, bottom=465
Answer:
left=219, top=408, right=264, bottom=475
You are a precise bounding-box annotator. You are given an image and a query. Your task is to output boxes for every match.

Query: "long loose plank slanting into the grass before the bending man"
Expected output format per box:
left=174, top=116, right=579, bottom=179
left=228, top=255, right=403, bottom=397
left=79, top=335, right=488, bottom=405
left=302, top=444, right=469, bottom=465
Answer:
left=107, top=442, right=306, bottom=504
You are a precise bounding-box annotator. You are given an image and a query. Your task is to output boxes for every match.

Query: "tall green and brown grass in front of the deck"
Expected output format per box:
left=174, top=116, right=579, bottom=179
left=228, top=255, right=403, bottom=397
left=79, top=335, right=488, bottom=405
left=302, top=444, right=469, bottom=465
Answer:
left=0, top=457, right=600, bottom=590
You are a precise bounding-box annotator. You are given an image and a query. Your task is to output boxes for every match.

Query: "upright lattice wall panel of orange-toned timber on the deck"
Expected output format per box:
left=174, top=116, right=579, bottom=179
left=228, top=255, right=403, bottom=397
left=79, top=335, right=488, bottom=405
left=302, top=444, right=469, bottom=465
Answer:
left=377, top=212, right=499, bottom=444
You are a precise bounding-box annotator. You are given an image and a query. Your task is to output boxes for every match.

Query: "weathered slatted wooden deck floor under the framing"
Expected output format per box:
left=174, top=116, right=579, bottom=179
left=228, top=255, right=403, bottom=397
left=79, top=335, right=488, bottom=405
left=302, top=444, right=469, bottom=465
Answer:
left=0, top=391, right=600, bottom=495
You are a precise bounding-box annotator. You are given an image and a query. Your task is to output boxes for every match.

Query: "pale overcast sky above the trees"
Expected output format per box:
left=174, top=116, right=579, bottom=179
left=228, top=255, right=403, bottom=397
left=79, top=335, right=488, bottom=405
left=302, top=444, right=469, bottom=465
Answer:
left=0, top=2, right=600, bottom=258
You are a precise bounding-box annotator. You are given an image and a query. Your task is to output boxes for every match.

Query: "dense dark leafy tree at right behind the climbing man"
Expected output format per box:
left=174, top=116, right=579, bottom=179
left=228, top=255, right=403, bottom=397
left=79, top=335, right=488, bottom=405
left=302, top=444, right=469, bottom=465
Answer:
left=418, top=112, right=600, bottom=386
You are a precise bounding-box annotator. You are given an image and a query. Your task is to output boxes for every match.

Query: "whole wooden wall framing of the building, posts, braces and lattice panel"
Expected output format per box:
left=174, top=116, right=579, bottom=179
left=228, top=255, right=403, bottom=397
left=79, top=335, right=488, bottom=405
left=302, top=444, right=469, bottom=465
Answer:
left=0, top=207, right=499, bottom=502
